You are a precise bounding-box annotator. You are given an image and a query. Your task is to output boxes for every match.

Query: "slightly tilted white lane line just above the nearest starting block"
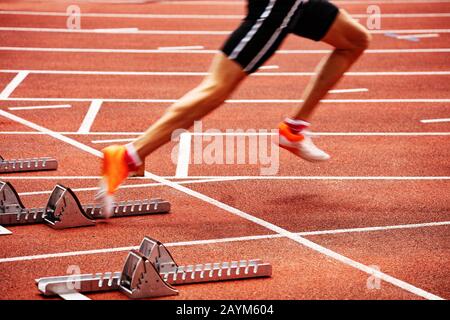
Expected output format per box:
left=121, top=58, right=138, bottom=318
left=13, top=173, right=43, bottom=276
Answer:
left=0, top=221, right=450, bottom=263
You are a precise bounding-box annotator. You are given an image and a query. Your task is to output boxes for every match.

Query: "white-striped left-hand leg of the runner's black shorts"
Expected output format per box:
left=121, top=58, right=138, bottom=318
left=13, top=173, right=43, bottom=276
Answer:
left=222, top=0, right=302, bottom=74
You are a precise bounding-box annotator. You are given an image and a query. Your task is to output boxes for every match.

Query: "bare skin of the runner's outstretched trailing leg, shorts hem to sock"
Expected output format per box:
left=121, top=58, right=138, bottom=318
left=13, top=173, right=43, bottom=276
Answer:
left=133, top=53, right=247, bottom=159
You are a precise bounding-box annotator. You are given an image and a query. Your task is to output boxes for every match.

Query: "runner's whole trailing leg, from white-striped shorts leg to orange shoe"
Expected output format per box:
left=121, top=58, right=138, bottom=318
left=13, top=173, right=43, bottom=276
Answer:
left=101, top=0, right=299, bottom=212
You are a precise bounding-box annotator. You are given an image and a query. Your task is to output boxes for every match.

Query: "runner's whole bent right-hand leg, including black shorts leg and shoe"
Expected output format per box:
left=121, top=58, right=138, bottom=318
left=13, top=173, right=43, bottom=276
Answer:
left=279, top=4, right=370, bottom=161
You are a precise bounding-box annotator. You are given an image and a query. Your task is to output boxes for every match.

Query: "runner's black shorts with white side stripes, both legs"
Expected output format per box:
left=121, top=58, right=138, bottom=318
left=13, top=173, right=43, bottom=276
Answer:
left=222, top=0, right=339, bottom=74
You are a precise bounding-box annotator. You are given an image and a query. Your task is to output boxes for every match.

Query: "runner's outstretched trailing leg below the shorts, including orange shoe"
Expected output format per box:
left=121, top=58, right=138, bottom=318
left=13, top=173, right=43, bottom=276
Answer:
left=100, top=53, right=247, bottom=199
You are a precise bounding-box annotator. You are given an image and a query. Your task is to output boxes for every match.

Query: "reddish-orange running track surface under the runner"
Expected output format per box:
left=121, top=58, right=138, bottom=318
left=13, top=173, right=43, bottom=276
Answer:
left=0, top=1, right=450, bottom=299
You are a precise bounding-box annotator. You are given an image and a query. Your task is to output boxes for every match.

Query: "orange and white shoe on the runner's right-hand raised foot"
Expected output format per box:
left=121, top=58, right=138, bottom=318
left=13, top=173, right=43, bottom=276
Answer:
left=278, top=122, right=330, bottom=162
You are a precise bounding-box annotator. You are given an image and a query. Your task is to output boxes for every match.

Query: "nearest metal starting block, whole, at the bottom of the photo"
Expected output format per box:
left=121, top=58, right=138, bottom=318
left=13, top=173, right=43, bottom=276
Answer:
left=36, top=237, right=272, bottom=299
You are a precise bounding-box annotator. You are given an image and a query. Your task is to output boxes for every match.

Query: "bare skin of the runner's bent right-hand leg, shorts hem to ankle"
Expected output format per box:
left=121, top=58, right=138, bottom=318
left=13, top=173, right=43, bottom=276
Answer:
left=293, top=10, right=371, bottom=121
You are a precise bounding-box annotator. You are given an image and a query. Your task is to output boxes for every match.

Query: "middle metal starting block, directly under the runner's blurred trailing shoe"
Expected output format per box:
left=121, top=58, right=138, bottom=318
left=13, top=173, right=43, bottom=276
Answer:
left=0, top=181, right=170, bottom=229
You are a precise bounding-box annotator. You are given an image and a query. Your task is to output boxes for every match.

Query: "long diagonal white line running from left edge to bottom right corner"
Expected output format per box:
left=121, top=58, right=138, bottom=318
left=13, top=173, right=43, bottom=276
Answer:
left=0, top=110, right=442, bottom=300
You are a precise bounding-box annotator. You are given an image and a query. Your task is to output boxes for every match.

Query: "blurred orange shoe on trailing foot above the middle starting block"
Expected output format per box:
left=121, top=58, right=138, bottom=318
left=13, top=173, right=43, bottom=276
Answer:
left=97, top=145, right=137, bottom=218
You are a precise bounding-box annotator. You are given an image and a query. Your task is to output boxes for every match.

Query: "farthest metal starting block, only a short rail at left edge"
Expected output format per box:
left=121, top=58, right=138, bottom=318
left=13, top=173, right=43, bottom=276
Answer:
left=0, top=156, right=58, bottom=173
